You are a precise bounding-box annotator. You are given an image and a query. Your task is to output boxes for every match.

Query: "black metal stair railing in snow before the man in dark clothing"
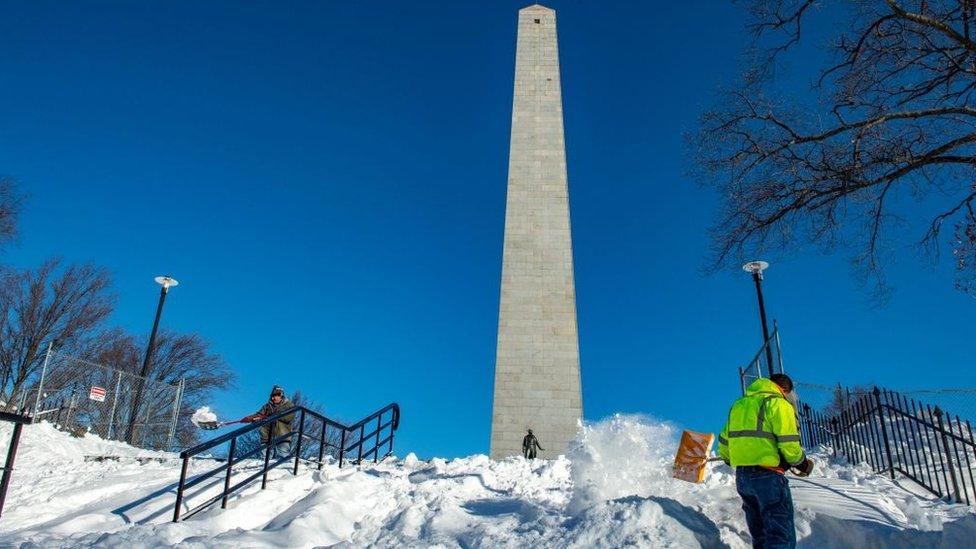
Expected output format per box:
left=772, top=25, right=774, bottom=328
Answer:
left=173, top=403, right=400, bottom=522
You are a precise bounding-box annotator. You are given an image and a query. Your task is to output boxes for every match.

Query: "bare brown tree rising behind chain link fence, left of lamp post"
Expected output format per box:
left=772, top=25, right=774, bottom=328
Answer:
left=0, top=260, right=114, bottom=409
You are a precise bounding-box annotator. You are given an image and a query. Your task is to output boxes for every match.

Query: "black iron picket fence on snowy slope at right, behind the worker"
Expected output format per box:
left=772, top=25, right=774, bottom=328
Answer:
left=798, top=387, right=976, bottom=505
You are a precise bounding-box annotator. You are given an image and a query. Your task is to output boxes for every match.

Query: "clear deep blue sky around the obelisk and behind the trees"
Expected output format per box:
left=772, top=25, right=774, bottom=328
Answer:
left=0, top=1, right=976, bottom=457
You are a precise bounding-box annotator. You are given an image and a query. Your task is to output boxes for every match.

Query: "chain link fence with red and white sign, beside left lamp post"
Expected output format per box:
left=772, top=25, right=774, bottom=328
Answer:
left=20, top=350, right=184, bottom=450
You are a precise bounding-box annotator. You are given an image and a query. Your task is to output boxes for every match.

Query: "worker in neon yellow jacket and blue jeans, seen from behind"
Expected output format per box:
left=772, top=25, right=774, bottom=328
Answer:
left=718, top=374, right=813, bottom=549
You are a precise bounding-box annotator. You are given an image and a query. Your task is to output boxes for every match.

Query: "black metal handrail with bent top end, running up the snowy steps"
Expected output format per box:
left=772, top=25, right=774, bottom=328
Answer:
left=173, top=402, right=400, bottom=522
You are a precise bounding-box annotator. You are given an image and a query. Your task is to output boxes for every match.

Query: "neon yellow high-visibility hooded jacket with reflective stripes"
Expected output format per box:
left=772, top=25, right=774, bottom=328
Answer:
left=718, top=378, right=806, bottom=469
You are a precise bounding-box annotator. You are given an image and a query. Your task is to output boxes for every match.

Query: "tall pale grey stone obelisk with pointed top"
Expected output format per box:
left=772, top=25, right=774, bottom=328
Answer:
left=491, top=4, right=583, bottom=458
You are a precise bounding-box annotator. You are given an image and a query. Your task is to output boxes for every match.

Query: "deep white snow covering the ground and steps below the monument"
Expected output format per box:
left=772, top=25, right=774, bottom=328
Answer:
left=0, top=416, right=976, bottom=548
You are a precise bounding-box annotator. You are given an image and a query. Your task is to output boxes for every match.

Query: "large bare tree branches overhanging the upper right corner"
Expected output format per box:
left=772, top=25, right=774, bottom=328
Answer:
left=693, top=0, right=976, bottom=296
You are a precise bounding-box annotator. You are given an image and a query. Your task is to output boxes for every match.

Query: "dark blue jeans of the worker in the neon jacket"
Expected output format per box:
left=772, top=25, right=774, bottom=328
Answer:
left=735, top=466, right=796, bottom=549
